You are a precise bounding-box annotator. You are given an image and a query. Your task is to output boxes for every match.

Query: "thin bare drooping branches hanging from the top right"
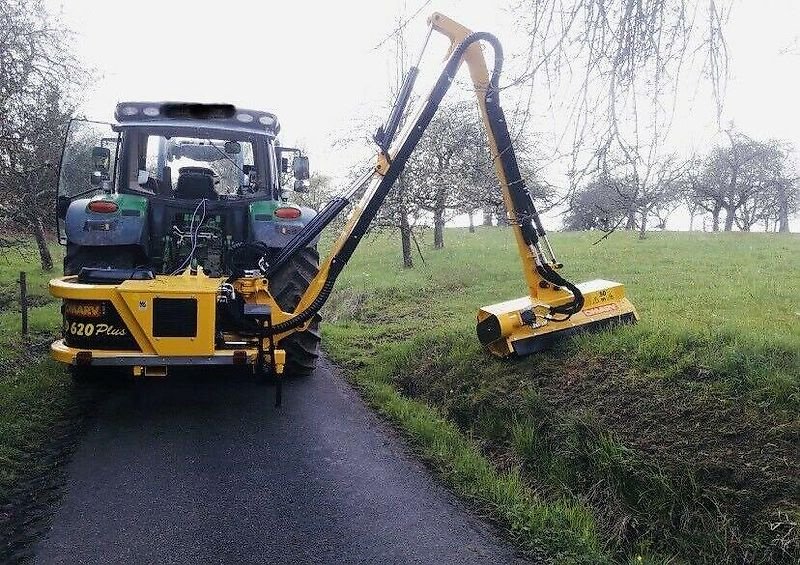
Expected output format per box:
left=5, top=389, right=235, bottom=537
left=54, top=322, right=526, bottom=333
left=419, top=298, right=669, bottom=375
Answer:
left=508, top=0, right=730, bottom=200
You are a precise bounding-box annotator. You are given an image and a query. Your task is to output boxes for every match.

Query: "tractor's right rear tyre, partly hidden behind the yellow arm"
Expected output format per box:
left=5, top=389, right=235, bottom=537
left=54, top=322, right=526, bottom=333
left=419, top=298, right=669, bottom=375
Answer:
left=269, top=247, right=321, bottom=377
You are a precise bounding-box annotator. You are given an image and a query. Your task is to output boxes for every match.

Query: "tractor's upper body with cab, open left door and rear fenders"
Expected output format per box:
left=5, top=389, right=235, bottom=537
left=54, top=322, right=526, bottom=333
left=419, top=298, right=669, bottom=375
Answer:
left=56, top=102, right=316, bottom=276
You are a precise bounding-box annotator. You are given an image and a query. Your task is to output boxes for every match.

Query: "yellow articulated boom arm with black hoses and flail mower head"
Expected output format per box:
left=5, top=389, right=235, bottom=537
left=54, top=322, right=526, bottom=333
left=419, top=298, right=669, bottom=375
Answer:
left=276, top=13, right=638, bottom=357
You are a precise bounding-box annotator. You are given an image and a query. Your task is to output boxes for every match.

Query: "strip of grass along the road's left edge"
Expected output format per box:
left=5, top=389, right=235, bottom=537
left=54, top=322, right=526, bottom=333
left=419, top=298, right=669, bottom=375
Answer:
left=0, top=246, right=91, bottom=562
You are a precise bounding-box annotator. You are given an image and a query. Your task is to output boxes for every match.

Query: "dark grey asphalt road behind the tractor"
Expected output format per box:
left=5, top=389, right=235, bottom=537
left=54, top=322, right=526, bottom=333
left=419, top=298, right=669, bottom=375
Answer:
left=35, top=360, right=522, bottom=565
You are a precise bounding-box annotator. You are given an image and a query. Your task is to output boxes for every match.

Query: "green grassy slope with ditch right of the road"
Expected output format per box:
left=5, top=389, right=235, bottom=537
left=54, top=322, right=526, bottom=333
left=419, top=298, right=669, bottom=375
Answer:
left=325, top=229, right=800, bottom=562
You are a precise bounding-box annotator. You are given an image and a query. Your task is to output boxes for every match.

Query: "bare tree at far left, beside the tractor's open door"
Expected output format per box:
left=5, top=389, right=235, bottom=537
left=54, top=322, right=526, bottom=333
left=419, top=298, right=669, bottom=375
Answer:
left=0, top=0, right=86, bottom=270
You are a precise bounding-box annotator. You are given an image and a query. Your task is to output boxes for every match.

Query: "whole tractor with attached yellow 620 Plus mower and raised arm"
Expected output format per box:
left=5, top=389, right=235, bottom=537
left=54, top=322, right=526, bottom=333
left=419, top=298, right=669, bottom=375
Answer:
left=50, top=13, right=638, bottom=401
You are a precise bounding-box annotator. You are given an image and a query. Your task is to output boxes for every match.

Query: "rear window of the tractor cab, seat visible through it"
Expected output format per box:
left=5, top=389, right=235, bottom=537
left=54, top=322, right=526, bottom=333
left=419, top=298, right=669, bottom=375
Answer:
left=135, top=135, right=255, bottom=200
